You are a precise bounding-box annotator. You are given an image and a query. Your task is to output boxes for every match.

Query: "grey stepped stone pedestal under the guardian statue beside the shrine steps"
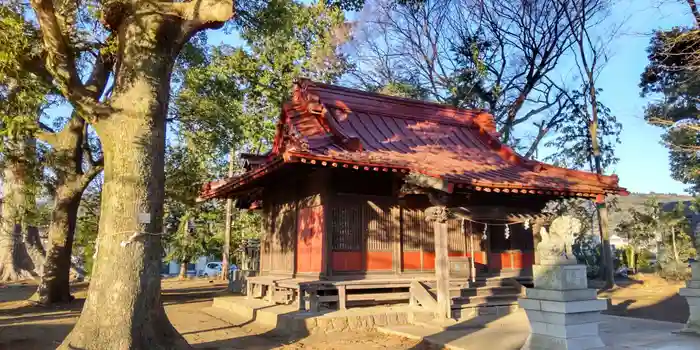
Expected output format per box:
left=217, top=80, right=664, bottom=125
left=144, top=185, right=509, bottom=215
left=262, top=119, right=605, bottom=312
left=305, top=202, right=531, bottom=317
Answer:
left=519, top=265, right=608, bottom=350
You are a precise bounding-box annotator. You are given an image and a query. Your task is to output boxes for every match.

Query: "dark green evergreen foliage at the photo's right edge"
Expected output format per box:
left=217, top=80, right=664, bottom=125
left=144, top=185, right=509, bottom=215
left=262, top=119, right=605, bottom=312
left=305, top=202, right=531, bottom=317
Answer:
left=639, top=28, right=700, bottom=193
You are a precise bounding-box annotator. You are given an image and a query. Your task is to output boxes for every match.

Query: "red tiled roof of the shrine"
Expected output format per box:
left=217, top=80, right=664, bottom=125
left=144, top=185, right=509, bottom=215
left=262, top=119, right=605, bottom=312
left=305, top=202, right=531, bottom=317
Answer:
left=198, top=80, right=625, bottom=197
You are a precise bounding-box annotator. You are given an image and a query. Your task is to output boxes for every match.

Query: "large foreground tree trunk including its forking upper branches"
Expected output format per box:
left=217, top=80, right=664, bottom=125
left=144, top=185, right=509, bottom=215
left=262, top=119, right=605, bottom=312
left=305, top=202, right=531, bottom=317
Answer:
left=31, top=0, right=233, bottom=350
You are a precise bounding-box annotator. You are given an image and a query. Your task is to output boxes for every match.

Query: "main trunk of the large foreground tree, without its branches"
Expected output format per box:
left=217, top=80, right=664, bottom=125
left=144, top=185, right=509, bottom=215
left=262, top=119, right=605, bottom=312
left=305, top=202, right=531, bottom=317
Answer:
left=60, top=18, right=189, bottom=349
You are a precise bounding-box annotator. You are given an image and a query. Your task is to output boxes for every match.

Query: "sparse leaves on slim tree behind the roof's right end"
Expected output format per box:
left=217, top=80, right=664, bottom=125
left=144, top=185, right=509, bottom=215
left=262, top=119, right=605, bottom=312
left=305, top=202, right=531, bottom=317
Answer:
left=545, top=90, right=622, bottom=172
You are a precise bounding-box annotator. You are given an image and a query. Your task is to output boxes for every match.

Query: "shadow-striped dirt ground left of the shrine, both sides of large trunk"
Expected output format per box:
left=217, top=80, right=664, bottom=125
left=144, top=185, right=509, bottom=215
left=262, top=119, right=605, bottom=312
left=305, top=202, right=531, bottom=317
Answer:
left=0, top=279, right=423, bottom=350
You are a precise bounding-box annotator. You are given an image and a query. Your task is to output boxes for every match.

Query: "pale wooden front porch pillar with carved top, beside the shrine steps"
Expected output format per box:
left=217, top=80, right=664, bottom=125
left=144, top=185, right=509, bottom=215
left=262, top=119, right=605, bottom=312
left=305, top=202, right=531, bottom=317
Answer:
left=426, top=206, right=452, bottom=320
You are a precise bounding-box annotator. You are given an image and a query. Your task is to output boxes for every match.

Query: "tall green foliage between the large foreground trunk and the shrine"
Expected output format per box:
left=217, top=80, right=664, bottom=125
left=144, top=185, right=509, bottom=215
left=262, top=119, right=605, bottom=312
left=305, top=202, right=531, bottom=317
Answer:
left=166, top=1, right=349, bottom=272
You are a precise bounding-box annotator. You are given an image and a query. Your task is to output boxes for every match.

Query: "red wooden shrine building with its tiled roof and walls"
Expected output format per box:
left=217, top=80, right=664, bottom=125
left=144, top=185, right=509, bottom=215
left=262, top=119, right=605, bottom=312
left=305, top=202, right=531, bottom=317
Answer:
left=201, top=80, right=624, bottom=298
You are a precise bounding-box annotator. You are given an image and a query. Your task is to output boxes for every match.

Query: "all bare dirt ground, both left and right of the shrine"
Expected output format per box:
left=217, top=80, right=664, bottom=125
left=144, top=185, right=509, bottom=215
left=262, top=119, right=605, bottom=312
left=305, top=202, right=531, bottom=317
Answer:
left=0, top=275, right=688, bottom=350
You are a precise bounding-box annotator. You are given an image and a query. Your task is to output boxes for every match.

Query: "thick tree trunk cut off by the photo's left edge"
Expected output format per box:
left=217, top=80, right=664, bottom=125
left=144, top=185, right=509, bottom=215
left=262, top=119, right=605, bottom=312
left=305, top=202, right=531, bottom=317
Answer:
left=0, top=139, right=41, bottom=282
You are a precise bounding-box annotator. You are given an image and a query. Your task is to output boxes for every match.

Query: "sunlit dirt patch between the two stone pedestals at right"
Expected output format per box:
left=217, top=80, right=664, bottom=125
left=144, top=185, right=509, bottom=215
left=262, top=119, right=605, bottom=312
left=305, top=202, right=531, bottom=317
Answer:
left=598, top=273, right=688, bottom=323
